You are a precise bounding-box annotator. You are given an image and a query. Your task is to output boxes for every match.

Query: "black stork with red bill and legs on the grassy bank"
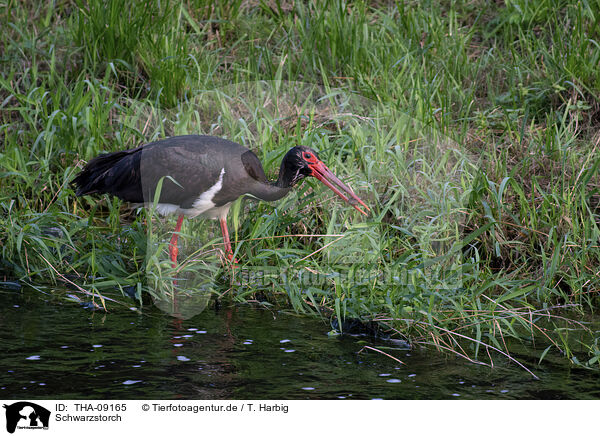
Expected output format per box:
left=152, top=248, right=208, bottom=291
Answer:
left=73, top=135, right=370, bottom=266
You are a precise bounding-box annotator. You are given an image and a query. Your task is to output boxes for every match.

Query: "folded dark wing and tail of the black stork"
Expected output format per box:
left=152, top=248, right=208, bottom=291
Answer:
left=74, top=135, right=266, bottom=208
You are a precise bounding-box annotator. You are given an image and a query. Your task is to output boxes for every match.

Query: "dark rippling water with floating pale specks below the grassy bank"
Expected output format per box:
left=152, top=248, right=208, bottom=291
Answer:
left=0, top=291, right=600, bottom=400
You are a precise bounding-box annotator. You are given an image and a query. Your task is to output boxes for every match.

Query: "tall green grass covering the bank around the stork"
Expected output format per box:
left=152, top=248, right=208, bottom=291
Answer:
left=0, top=0, right=600, bottom=369
